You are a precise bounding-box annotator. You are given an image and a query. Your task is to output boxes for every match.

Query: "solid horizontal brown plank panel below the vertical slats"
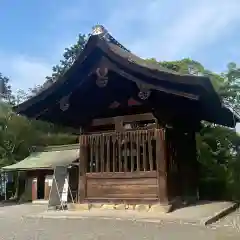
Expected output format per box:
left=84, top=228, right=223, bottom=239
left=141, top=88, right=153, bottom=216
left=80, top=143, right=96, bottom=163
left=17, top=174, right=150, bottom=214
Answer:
left=87, top=172, right=158, bottom=201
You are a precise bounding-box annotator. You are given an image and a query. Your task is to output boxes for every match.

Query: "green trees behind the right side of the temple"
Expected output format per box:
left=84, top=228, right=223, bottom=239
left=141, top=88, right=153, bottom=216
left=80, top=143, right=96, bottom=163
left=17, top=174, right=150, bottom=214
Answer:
left=157, top=59, right=240, bottom=200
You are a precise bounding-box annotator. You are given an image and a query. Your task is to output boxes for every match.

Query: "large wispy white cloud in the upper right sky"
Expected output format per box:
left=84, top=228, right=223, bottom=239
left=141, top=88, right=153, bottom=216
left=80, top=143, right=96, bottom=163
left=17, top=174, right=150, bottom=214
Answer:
left=103, top=0, right=240, bottom=60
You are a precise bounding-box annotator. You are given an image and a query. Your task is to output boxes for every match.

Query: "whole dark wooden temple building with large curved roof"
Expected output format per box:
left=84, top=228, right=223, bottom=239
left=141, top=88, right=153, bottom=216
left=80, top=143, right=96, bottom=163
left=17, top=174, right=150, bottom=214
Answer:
left=15, top=26, right=239, bottom=211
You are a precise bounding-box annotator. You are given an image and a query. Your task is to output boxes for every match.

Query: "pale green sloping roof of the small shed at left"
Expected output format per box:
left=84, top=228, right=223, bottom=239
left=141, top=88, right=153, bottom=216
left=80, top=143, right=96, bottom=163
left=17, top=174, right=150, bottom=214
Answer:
left=2, top=144, right=79, bottom=171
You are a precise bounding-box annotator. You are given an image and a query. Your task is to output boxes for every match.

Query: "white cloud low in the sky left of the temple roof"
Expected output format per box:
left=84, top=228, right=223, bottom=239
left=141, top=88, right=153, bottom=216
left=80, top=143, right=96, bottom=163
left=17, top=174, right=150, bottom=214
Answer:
left=0, top=39, right=80, bottom=92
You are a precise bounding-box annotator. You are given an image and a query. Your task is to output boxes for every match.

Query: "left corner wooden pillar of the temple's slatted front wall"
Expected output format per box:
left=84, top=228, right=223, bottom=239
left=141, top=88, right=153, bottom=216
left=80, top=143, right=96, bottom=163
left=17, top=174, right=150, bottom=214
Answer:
left=78, top=135, right=88, bottom=203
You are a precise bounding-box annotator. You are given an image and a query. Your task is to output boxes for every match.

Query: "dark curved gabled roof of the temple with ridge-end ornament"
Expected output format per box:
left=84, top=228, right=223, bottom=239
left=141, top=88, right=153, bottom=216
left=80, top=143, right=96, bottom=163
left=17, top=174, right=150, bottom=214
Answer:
left=15, top=25, right=239, bottom=126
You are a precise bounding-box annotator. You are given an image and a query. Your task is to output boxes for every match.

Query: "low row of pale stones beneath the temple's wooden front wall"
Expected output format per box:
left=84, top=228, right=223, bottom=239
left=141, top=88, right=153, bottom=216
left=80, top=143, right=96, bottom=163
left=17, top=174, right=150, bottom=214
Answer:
left=69, top=203, right=172, bottom=213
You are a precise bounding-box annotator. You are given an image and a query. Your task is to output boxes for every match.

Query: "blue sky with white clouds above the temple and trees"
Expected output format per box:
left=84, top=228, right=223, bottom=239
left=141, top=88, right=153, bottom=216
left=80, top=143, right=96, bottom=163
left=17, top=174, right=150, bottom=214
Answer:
left=0, top=0, right=240, bottom=130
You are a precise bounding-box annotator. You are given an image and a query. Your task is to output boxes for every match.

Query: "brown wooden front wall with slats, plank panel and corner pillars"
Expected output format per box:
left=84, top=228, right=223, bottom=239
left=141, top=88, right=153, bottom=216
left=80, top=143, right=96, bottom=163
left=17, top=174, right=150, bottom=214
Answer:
left=79, top=128, right=167, bottom=202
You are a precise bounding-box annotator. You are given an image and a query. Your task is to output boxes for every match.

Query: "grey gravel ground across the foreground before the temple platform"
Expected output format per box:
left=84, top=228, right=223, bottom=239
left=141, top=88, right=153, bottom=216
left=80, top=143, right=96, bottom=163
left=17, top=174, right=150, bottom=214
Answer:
left=0, top=205, right=240, bottom=240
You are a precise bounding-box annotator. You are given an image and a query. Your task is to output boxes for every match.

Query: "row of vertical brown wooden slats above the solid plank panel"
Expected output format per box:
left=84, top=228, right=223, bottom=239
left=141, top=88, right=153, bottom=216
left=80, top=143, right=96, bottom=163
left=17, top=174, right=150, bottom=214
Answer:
left=80, top=129, right=164, bottom=173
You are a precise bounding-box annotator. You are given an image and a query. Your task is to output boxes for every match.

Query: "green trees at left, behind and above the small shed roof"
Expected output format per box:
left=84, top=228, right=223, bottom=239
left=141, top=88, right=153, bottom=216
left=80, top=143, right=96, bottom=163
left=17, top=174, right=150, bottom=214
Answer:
left=0, top=72, right=77, bottom=167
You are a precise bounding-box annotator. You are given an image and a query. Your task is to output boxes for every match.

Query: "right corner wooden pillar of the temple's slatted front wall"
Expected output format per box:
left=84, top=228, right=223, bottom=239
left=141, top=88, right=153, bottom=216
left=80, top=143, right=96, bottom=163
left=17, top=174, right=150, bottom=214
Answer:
left=156, top=129, right=169, bottom=204
